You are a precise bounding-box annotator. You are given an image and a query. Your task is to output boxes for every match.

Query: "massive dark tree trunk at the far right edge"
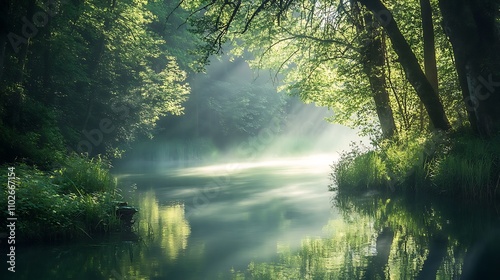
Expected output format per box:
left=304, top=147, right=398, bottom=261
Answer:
left=439, top=0, right=500, bottom=137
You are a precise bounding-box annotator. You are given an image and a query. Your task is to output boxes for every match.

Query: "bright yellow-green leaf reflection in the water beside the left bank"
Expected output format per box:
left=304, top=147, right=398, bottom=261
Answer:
left=110, top=190, right=203, bottom=279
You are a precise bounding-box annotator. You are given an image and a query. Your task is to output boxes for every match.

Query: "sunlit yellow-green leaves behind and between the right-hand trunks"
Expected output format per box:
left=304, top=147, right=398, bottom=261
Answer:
left=185, top=1, right=467, bottom=138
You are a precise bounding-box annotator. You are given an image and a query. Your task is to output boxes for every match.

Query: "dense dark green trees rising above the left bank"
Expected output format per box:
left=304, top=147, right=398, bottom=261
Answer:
left=0, top=0, right=196, bottom=164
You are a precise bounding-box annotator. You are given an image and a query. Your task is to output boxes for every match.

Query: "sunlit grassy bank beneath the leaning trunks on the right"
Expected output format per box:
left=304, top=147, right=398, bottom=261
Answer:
left=332, top=132, right=500, bottom=199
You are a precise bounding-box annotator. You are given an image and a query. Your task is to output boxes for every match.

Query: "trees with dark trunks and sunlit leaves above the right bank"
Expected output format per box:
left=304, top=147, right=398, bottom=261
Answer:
left=181, top=0, right=500, bottom=138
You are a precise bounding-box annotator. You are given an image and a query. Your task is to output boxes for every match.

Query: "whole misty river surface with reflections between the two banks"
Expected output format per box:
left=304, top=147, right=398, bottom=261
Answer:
left=5, top=155, right=500, bottom=280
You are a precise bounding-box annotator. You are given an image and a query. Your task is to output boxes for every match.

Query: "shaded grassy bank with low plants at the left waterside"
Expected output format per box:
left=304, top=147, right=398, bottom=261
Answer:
left=0, top=155, right=120, bottom=241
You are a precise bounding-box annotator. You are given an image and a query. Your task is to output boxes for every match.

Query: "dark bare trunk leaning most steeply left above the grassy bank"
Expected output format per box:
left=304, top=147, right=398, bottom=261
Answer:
left=358, top=0, right=451, bottom=130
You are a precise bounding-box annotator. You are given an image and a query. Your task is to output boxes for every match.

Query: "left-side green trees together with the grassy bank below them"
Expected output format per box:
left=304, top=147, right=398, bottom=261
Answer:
left=0, top=0, right=205, bottom=240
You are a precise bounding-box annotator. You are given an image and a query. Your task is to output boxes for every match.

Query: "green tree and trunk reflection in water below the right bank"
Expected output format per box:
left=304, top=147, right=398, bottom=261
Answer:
left=233, top=192, right=500, bottom=279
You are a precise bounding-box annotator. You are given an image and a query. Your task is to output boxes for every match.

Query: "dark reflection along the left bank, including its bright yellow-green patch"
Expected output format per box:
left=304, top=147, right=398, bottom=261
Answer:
left=0, top=191, right=200, bottom=280
